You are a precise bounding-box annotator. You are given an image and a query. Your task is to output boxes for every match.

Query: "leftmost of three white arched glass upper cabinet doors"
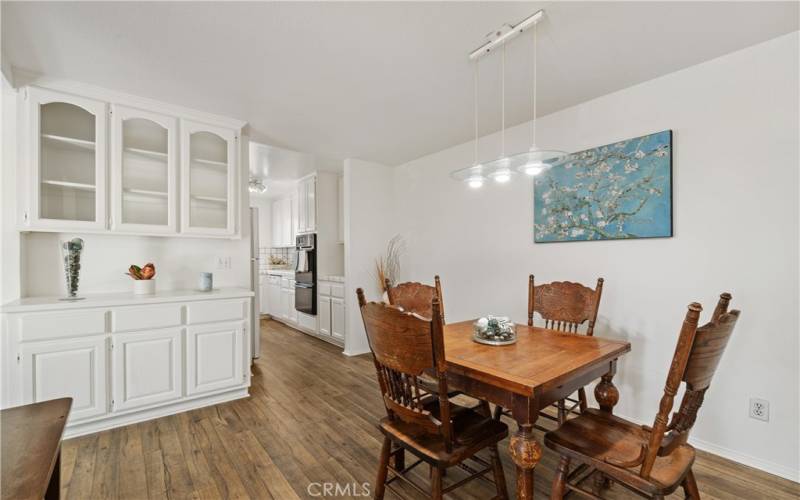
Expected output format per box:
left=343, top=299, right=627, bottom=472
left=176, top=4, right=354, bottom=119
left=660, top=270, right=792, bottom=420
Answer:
left=25, top=87, right=108, bottom=231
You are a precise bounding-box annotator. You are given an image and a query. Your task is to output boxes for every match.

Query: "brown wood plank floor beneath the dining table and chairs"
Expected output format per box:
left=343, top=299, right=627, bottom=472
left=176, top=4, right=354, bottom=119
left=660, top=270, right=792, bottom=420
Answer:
left=62, top=321, right=800, bottom=500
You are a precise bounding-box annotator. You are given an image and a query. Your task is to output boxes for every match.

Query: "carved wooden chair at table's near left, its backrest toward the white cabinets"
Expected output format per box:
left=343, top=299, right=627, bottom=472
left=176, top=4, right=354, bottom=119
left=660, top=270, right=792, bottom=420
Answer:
left=357, top=288, right=508, bottom=500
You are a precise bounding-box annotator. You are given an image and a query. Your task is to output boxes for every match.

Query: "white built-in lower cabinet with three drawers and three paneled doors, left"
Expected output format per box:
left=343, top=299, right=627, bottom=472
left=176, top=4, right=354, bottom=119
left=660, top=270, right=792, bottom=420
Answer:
left=0, top=289, right=252, bottom=437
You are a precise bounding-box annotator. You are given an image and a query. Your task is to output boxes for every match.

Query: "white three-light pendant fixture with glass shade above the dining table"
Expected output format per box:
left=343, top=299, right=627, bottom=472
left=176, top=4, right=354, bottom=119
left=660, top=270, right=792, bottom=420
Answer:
left=450, top=10, right=567, bottom=188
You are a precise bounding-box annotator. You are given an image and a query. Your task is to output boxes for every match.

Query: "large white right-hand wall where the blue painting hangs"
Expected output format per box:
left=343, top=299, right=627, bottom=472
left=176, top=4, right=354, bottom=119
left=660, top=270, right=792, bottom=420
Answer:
left=392, top=32, right=800, bottom=480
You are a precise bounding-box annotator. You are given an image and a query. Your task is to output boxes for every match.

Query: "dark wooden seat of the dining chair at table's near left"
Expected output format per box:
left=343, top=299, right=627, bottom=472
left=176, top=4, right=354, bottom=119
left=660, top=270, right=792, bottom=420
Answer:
left=379, top=400, right=508, bottom=467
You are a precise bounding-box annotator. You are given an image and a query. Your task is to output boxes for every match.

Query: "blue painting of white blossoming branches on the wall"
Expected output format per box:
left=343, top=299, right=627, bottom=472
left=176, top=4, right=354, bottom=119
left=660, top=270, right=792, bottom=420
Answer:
left=533, top=130, right=672, bottom=243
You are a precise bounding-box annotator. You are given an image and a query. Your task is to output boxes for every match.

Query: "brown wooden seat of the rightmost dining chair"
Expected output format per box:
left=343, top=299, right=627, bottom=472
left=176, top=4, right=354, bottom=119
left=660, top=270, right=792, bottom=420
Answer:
left=544, top=409, right=695, bottom=495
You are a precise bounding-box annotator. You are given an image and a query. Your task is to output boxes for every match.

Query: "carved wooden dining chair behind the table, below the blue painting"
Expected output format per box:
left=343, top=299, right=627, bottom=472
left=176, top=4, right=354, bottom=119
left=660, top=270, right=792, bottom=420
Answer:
left=495, top=274, right=604, bottom=431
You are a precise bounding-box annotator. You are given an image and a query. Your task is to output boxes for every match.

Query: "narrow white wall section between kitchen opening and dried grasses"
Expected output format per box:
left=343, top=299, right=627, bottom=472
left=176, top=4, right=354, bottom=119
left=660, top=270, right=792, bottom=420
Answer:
left=344, top=159, right=396, bottom=356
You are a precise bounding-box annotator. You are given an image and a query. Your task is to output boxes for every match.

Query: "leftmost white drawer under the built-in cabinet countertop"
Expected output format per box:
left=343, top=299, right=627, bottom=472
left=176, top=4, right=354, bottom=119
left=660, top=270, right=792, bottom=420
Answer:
left=17, top=309, right=106, bottom=342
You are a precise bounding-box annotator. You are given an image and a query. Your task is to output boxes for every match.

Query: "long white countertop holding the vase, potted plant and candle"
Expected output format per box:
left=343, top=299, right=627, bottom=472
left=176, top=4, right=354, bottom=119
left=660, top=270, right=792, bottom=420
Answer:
left=0, top=288, right=253, bottom=313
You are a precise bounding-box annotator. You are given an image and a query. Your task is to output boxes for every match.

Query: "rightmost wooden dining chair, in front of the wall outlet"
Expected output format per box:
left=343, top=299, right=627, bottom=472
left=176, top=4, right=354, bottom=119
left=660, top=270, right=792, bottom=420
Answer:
left=545, top=293, right=739, bottom=500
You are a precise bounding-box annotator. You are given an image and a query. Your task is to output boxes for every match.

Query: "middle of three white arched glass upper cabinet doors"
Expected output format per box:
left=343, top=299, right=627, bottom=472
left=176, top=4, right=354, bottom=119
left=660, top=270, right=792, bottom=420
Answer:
left=111, top=105, right=178, bottom=234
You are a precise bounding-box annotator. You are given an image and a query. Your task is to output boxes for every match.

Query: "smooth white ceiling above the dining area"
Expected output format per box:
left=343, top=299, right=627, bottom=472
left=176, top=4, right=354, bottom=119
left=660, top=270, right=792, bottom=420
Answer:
left=2, top=2, right=799, bottom=164
